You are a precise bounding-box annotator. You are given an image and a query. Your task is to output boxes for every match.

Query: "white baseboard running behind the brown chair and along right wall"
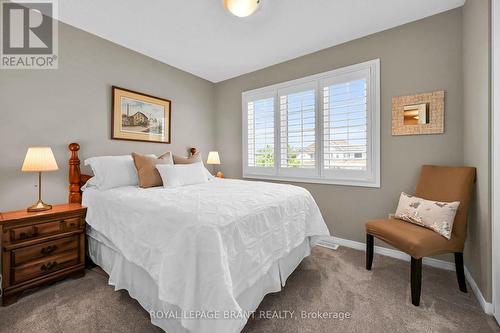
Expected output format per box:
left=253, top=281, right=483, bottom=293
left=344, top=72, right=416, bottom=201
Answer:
left=318, top=233, right=493, bottom=315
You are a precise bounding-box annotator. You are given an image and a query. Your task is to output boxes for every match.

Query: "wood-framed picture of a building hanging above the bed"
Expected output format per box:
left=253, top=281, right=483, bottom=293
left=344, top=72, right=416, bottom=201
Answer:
left=111, top=86, right=172, bottom=143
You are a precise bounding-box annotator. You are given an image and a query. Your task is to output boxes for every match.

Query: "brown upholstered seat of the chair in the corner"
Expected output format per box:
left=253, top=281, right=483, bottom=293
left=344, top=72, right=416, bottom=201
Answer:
left=366, top=219, right=463, bottom=259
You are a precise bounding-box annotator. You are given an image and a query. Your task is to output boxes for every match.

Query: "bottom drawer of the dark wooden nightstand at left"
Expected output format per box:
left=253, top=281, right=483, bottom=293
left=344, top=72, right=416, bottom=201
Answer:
left=12, top=251, right=79, bottom=284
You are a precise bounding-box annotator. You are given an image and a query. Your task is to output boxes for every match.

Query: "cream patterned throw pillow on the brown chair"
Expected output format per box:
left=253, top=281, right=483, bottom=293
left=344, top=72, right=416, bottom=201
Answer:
left=395, top=192, right=460, bottom=239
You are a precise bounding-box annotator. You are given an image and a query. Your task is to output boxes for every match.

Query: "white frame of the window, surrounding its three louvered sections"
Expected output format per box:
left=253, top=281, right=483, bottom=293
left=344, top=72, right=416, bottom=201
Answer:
left=242, top=59, right=380, bottom=188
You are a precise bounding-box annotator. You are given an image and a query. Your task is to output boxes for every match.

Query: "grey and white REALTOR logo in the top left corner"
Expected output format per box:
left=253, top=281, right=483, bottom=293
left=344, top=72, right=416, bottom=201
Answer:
left=0, top=0, right=58, bottom=69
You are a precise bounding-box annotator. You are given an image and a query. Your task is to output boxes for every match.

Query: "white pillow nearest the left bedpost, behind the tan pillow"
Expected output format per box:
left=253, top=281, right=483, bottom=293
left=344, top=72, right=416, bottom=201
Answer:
left=84, top=155, right=139, bottom=190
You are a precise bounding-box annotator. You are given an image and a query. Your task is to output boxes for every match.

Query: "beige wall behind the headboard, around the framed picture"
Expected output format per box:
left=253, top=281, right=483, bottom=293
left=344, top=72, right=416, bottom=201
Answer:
left=0, top=23, right=215, bottom=211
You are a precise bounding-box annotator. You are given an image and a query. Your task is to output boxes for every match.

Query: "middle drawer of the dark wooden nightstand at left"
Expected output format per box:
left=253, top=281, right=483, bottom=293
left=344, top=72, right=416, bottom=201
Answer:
left=12, top=236, right=79, bottom=266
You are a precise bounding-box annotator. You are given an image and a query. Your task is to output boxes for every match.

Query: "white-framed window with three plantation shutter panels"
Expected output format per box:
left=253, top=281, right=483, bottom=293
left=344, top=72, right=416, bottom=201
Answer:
left=242, top=59, right=380, bottom=187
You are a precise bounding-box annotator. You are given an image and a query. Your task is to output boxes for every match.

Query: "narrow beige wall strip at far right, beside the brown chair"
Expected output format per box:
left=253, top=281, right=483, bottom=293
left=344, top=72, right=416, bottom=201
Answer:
left=462, top=0, right=491, bottom=302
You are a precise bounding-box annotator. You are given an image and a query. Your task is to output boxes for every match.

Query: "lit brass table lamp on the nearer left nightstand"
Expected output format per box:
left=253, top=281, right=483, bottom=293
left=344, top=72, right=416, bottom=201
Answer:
left=21, top=147, right=59, bottom=212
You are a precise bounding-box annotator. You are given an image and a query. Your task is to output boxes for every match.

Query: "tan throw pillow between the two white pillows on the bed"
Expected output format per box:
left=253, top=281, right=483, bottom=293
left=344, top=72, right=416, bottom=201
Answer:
left=132, top=152, right=174, bottom=188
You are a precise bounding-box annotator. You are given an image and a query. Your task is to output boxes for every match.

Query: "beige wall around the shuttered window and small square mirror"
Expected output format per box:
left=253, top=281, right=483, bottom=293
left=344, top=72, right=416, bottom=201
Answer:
left=216, top=12, right=463, bottom=258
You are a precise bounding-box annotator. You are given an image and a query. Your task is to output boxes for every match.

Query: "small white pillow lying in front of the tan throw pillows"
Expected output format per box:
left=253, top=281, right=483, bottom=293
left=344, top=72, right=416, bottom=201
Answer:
left=156, top=163, right=208, bottom=187
